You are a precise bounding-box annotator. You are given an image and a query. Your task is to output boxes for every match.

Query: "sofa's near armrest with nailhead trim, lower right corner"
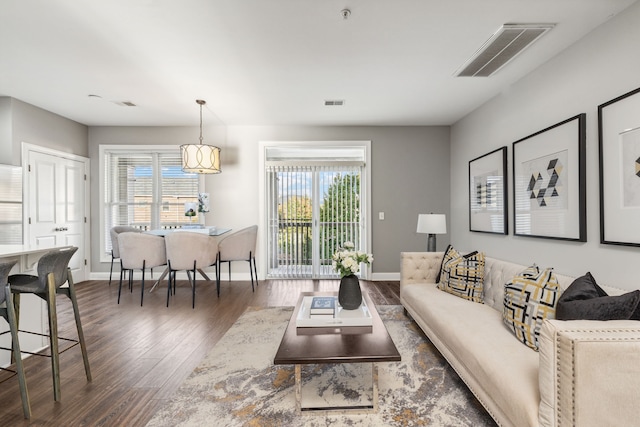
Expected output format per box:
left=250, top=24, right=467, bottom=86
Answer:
left=539, top=320, right=640, bottom=427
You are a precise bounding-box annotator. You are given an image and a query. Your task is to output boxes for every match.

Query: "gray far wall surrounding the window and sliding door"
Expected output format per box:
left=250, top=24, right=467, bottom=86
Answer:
left=89, top=126, right=449, bottom=278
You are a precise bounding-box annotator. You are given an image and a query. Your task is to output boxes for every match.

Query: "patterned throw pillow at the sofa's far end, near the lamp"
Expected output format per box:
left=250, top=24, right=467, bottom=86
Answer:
left=438, top=251, right=485, bottom=303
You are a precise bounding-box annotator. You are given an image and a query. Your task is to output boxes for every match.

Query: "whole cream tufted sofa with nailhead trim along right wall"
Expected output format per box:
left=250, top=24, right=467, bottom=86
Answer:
left=400, top=252, right=640, bottom=427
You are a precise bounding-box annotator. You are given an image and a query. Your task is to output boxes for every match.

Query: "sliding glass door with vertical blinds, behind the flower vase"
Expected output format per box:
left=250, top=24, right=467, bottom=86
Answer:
left=266, top=145, right=366, bottom=278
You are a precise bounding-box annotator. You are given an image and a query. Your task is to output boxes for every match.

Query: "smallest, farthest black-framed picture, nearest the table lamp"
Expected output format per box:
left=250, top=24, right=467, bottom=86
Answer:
left=469, top=147, right=509, bottom=234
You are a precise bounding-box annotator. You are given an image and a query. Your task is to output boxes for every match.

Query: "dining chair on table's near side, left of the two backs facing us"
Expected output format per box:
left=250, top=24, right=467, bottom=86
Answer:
left=118, top=232, right=167, bottom=307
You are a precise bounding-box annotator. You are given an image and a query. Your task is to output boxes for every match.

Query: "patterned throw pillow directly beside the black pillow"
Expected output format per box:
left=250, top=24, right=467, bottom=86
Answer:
left=502, top=265, right=561, bottom=351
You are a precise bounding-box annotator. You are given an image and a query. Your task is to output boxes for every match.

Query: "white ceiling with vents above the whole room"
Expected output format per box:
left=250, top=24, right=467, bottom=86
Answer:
left=0, top=0, right=635, bottom=126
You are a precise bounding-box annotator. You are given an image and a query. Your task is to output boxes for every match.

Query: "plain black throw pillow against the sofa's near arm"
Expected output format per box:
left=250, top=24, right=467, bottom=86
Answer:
left=556, top=272, right=640, bottom=320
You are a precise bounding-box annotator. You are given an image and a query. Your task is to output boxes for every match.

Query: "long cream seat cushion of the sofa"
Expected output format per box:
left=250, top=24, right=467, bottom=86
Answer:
left=402, top=280, right=540, bottom=426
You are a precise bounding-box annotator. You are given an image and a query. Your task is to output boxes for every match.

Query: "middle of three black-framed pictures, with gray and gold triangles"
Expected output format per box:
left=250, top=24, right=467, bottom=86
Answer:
left=513, top=113, right=587, bottom=242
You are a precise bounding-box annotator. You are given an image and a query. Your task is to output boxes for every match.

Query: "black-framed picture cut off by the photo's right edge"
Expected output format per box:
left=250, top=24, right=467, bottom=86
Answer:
left=598, top=88, right=640, bottom=246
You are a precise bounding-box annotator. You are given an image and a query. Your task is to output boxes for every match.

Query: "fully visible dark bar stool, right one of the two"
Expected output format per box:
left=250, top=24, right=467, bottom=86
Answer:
left=9, top=247, right=91, bottom=402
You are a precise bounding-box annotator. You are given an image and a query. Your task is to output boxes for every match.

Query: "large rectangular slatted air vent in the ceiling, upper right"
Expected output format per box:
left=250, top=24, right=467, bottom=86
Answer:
left=455, top=24, right=555, bottom=77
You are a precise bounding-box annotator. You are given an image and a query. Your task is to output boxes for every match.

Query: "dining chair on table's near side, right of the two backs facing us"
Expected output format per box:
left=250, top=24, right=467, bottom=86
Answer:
left=164, top=231, right=218, bottom=308
